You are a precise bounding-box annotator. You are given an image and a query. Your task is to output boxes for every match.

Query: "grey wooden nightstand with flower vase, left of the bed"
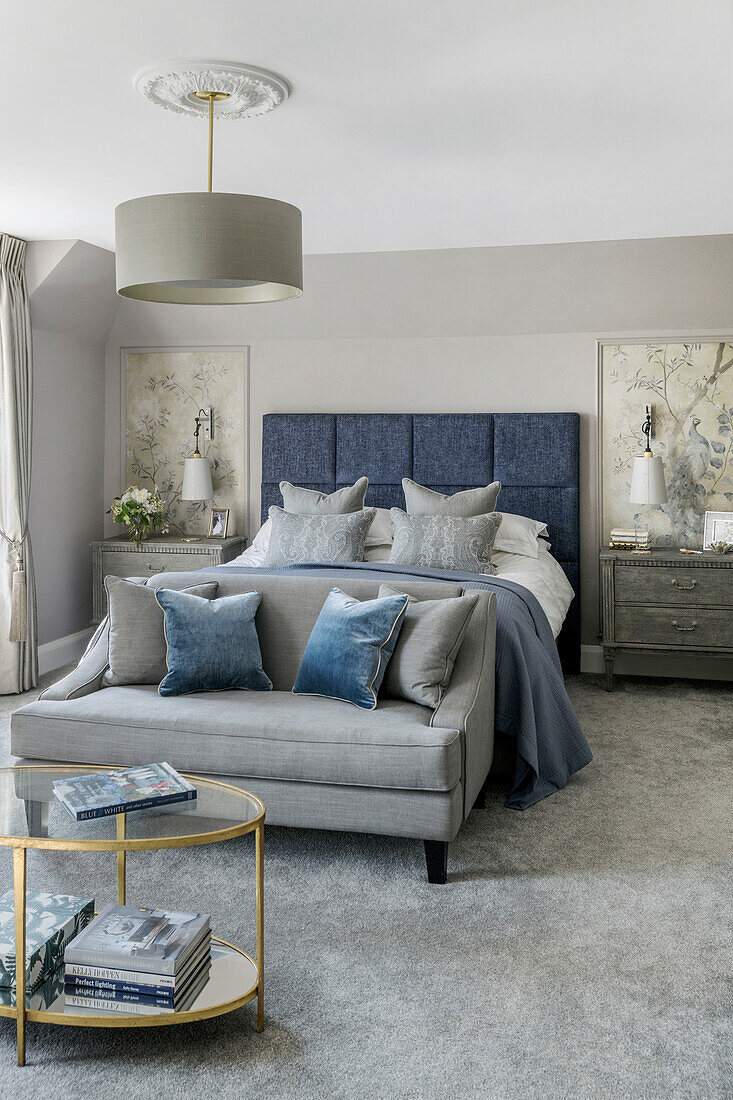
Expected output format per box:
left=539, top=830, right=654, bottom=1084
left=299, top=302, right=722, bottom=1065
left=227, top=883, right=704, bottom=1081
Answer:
left=91, top=535, right=247, bottom=623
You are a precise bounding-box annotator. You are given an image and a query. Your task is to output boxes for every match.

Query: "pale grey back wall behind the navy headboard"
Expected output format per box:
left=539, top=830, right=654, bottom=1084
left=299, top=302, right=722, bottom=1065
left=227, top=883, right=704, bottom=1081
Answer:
left=106, top=235, right=733, bottom=644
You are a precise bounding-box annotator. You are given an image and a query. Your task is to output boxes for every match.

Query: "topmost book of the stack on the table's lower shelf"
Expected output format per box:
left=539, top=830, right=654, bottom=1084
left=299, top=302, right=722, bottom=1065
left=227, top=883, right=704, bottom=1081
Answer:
left=65, top=905, right=211, bottom=976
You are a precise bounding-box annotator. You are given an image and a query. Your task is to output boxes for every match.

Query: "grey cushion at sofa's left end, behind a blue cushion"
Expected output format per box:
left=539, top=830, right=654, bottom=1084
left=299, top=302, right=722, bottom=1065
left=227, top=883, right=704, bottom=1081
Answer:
left=105, top=576, right=219, bottom=688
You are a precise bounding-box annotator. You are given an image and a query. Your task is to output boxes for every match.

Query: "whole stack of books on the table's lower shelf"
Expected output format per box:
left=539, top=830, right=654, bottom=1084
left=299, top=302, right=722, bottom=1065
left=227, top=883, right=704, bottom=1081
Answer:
left=64, top=905, right=211, bottom=1015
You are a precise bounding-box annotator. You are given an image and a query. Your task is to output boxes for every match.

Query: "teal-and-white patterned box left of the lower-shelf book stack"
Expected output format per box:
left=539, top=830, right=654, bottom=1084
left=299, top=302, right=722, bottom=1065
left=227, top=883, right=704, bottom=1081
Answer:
left=0, top=890, right=95, bottom=990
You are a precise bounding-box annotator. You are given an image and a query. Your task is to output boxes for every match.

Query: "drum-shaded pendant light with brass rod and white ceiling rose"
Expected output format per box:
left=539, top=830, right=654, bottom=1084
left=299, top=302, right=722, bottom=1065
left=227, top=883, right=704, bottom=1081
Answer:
left=114, top=61, right=303, bottom=306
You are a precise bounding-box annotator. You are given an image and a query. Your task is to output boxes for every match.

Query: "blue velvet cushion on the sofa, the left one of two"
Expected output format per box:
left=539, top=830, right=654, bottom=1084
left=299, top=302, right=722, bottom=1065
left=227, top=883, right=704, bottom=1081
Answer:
left=155, top=589, right=272, bottom=695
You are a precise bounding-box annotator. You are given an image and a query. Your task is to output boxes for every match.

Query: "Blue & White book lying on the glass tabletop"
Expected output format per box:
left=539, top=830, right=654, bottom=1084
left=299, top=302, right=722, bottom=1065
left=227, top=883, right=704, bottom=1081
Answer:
left=54, top=762, right=196, bottom=822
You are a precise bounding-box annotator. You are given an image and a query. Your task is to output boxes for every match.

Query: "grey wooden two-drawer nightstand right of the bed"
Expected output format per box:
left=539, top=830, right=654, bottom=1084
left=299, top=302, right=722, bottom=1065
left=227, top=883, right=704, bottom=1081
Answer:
left=600, top=550, right=733, bottom=691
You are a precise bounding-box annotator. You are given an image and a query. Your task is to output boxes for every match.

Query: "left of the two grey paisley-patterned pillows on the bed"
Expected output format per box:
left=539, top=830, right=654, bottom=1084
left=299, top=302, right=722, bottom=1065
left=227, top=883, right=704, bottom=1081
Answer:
left=262, top=505, right=376, bottom=565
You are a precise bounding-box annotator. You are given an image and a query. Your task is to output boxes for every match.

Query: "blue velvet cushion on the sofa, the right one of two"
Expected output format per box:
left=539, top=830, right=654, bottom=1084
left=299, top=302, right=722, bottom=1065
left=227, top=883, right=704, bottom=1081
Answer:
left=290, top=589, right=409, bottom=711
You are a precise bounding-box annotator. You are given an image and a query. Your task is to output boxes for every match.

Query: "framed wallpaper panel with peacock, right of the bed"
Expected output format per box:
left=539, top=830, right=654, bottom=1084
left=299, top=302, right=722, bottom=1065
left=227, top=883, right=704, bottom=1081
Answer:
left=600, top=340, right=733, bottom=549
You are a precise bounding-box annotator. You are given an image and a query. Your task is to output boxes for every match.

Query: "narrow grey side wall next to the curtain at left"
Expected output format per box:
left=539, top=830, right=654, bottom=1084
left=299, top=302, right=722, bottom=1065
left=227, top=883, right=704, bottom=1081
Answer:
left=28, top=241, right=117, bottom=642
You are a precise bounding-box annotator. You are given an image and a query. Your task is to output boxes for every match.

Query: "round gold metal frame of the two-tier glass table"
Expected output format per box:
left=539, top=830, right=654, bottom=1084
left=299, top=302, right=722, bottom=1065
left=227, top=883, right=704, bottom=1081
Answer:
left=0, top=765, right=265, bottom=1066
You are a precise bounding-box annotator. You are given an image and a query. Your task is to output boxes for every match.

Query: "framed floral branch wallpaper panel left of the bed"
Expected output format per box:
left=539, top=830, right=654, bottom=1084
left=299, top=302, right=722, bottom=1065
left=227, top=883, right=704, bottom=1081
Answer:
left=125, top=349, right=245, bottom=535
